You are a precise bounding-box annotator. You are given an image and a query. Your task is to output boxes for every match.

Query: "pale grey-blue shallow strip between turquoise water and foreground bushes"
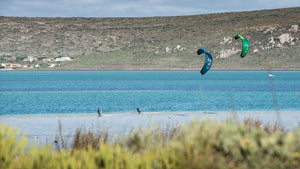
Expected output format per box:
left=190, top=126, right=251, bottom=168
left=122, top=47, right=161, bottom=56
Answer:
left=0, top=111, right=300, bottom=143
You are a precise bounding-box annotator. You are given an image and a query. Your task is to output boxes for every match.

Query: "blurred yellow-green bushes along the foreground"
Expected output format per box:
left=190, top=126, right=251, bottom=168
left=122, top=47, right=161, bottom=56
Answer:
left=0, top=121, right=300, bottom=169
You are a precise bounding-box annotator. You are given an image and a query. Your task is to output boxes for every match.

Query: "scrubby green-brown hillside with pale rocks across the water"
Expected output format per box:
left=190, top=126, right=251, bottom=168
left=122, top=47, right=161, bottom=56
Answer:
left=0, top=7, right=300, bottom=70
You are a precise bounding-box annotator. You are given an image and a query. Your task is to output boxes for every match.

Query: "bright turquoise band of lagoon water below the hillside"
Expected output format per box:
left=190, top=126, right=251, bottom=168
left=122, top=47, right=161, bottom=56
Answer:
left=0, top=71, right=300, bottom=115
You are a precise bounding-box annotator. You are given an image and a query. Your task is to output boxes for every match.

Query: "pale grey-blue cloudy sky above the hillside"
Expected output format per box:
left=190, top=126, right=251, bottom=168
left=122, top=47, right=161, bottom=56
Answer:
left=0, top=0, right=300, bottom=17
